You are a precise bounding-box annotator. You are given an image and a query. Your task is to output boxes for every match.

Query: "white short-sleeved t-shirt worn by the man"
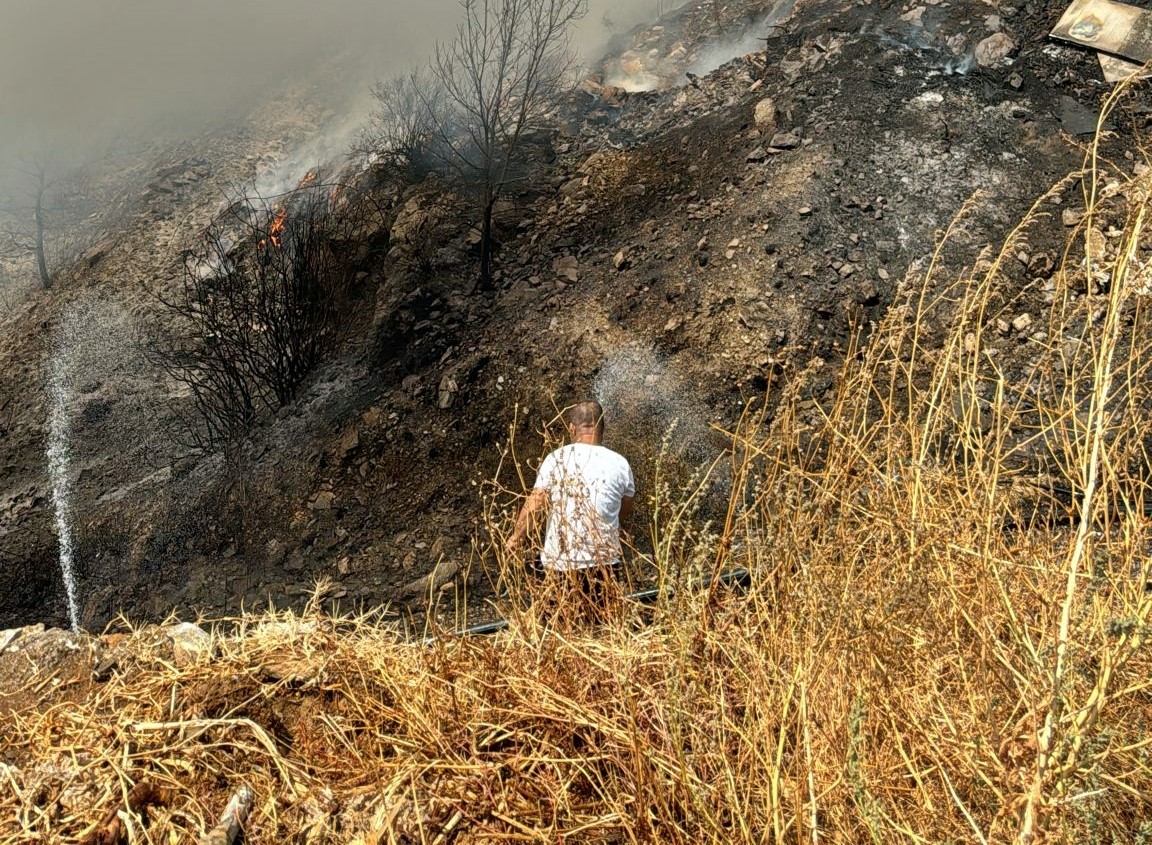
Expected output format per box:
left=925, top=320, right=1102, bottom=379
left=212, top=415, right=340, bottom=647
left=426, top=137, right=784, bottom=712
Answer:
left=536, top=443, right=636, bottom=570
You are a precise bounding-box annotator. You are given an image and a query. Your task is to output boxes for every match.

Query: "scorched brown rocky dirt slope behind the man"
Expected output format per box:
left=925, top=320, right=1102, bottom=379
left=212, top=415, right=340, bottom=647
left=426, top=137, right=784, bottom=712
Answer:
left=0, top=0, right=1150, bottom=629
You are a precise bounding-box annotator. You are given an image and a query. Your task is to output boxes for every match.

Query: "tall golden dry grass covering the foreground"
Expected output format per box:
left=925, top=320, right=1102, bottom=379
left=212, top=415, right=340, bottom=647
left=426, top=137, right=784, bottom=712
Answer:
left=11, top=90, right=1152, bottom=845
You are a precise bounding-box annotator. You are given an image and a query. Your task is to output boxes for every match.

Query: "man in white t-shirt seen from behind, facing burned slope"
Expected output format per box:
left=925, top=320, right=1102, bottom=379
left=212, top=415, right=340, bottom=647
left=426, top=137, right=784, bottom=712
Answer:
left=507, top=402, right=636, bottom=615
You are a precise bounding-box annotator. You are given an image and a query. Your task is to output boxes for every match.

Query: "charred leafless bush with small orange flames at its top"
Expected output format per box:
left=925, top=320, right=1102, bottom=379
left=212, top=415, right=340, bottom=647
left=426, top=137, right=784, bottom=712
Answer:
left=152, top=185, right=357, bottom=450
